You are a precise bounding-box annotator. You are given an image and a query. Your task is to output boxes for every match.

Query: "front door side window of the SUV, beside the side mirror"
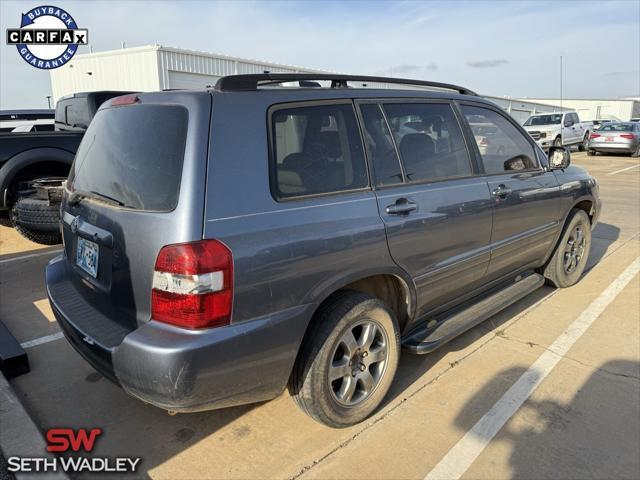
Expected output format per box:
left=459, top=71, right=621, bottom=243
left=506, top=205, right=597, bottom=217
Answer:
left=462, top=105, right=538, bottom=174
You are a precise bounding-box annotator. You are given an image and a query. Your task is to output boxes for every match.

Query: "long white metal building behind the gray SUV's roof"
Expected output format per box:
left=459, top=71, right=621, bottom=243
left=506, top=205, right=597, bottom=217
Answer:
left=51, top=45, right=559, bottom=123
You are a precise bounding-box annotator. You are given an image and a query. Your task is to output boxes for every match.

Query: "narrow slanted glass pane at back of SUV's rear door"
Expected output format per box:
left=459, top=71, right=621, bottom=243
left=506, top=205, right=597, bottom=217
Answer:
left=360, top=104, right=402, bottom=186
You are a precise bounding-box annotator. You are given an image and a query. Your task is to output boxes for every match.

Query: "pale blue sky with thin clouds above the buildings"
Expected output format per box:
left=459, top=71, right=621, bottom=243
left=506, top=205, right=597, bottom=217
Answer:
left=0, top=0, right=640, bottom=109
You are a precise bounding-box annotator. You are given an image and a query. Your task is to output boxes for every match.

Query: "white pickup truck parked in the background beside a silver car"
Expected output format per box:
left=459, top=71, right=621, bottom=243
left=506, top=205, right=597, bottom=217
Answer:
left=523, top=112, right=593, bottom=151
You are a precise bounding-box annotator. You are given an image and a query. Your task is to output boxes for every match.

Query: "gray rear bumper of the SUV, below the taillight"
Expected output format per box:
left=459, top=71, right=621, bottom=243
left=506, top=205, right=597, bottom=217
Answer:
left=46, top=257, right=313, bottom=412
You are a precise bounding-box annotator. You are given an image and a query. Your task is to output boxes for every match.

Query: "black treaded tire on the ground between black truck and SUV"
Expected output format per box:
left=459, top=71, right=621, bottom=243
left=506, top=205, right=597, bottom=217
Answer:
left=11, top=196, right=62, bottom=245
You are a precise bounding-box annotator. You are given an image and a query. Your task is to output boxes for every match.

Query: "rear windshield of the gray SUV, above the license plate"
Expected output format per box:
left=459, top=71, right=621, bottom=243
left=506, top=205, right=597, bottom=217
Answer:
left=69, top=105, right=188, bottom=211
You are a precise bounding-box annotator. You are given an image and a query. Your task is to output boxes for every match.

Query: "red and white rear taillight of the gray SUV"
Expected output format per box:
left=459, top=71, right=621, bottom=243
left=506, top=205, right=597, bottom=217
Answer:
left=151, top=240, right=233, bottom=328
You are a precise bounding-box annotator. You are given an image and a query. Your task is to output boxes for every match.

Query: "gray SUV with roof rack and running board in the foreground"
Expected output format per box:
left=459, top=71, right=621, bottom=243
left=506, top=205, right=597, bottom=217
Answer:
left=46, top=74, right=600, bottom=427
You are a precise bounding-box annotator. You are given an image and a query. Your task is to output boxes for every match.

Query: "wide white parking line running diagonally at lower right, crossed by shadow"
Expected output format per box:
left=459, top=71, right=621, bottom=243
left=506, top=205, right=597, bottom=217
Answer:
left=425, top=257, right=640, bottom=480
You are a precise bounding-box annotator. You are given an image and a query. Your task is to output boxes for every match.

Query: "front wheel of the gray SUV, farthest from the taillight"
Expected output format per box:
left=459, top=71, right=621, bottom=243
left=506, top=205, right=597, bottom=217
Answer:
left=543, top=209, right=591, bottom=288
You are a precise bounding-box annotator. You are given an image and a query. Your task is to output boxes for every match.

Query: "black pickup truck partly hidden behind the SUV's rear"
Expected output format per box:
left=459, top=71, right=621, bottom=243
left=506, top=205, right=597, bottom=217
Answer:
left=0, top=91, right=129, bottom=245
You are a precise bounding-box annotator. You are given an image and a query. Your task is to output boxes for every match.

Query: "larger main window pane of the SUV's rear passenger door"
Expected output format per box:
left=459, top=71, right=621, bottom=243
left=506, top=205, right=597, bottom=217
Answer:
left=384, top=103, right=471, bottom=181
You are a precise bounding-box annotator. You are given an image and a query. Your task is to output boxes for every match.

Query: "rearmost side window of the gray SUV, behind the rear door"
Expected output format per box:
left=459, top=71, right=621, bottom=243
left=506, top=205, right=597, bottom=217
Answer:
left=271, top=104, right=369, bottom=198
